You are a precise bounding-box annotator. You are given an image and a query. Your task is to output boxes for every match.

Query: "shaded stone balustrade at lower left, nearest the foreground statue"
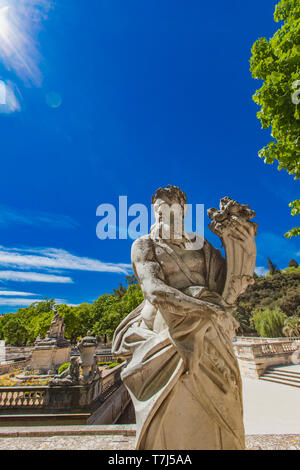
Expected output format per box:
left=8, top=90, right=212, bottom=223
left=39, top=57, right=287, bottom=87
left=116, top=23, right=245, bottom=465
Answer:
left=0, top=363, right=125, bottom=414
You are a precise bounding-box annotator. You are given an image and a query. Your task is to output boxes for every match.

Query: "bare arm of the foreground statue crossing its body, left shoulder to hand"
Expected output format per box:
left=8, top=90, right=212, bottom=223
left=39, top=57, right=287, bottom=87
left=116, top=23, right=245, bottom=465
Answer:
left=131, top=238, right=224, bottom=314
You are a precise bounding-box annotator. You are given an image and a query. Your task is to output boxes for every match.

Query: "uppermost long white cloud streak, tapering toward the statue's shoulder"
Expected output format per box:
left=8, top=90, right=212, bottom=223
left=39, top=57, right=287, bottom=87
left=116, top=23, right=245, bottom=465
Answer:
left=0, top=247, right=132, bottom=274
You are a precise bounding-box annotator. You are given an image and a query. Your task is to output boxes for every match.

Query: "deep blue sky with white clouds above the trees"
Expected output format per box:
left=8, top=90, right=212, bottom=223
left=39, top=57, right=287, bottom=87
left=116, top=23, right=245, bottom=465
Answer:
left=0, top=0, right=300, bottom=313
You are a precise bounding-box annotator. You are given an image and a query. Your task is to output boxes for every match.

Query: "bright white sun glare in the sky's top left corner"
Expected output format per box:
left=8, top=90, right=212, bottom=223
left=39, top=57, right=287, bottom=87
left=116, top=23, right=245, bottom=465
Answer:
left=0, top=0, right=53, bottom=86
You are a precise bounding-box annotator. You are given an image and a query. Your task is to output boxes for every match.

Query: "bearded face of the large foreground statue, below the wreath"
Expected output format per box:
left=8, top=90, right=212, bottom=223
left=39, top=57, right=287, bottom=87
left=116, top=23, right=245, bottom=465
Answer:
left=153, top=199, right=186, bottom=240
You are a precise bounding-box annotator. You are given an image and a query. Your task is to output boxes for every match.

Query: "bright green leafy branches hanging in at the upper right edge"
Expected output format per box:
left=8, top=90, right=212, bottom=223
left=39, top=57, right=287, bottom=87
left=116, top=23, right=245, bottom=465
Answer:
left=250, top=0, right=300, bottom=238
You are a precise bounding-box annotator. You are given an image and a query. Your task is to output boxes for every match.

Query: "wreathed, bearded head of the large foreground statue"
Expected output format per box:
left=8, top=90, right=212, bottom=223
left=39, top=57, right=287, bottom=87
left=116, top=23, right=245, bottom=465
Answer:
left=151, top=184, right=187, bottom=242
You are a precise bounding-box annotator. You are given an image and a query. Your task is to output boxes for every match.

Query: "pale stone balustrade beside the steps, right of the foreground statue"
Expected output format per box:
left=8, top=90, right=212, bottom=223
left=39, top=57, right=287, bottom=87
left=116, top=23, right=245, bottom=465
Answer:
left=233, top=338, right=300, bottom=378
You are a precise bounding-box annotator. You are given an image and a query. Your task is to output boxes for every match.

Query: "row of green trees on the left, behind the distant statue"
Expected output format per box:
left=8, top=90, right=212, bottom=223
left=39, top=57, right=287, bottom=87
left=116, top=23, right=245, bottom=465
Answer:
left=0, top=276, right=143, bottom=346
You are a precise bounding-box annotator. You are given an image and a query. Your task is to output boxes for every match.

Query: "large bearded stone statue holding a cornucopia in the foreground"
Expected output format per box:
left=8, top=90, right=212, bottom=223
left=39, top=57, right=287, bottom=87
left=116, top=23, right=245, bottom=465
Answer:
left=113, top=185, right=257, bottom=449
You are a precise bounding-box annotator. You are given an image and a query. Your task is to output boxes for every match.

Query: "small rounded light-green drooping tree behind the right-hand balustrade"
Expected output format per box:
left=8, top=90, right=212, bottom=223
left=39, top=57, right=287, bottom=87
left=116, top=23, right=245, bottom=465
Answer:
left=252, top=307, right=286, bottom=338
